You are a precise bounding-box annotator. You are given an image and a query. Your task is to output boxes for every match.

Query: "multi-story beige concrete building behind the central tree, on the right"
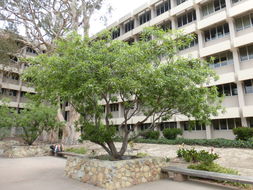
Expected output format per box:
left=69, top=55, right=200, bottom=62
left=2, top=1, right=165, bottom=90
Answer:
left=101, top=0, right=253, bottom=139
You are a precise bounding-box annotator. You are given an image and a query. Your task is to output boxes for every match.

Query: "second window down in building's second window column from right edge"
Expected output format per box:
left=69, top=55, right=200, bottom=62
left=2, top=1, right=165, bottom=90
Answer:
left=204, top=23, right=229, bottom=42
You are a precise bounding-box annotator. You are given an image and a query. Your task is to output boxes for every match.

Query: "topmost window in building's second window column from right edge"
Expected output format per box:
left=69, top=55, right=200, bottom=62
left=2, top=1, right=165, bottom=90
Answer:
left=202, top=0, right=226, bottom=16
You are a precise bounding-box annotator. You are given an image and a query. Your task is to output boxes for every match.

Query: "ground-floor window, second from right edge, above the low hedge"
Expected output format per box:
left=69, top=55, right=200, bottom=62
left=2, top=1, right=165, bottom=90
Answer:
left=212, top=118, right=242, bottom=130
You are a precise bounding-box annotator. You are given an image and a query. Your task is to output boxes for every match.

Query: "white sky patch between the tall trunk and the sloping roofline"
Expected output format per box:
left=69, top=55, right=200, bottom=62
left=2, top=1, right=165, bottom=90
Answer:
left=90, top=0, right=148, bottom=35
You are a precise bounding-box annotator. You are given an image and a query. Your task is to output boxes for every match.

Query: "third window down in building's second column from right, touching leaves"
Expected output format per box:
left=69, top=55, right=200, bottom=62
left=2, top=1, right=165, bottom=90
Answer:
left=207, top=51, right=234, bottom=68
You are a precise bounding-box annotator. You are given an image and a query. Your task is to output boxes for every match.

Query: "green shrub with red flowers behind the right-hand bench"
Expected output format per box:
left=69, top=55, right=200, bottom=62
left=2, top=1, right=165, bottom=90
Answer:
left=177, top=148, right=219, bottom=164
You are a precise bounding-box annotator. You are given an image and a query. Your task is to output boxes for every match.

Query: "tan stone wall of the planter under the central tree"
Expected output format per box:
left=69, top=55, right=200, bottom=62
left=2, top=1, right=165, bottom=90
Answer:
left=65, top=157, right=168, bottom=190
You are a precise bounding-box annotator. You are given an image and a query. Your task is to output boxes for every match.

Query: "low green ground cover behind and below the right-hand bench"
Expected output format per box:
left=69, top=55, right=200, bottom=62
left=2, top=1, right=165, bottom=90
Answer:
left=188, top=163, right=249, bottom=188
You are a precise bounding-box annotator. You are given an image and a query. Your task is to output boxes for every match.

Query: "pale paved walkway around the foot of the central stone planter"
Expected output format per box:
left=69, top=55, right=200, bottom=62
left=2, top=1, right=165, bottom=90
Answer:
left=0, top=157, right=233, bottom=190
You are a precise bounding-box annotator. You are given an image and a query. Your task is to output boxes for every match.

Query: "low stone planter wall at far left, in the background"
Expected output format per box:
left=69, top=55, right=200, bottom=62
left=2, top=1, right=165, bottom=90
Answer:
left=3, top=145, right=50, bottom=158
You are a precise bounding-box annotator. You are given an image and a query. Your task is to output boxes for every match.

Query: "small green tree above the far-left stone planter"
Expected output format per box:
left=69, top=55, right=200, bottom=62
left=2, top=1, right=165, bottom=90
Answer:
left=0, top=102, right=63, bottom=145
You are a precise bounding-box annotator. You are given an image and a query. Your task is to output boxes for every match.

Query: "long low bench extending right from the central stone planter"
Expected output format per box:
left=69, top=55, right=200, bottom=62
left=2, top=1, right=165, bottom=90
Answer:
left=161, top=166, right=253, bottom=184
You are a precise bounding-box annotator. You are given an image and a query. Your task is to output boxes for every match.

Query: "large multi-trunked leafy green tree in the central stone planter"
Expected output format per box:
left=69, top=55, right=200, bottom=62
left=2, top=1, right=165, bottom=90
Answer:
left=24, top=28, right=220, bottom=159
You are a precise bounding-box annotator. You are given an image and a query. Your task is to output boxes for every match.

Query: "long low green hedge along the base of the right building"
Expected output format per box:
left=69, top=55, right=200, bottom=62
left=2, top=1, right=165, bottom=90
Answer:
left=131, top=138, right=253, bottom=149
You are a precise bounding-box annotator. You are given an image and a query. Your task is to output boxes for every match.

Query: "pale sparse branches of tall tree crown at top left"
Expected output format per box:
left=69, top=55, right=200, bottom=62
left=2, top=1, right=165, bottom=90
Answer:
left=0, top=0, right=110, bottom=53
